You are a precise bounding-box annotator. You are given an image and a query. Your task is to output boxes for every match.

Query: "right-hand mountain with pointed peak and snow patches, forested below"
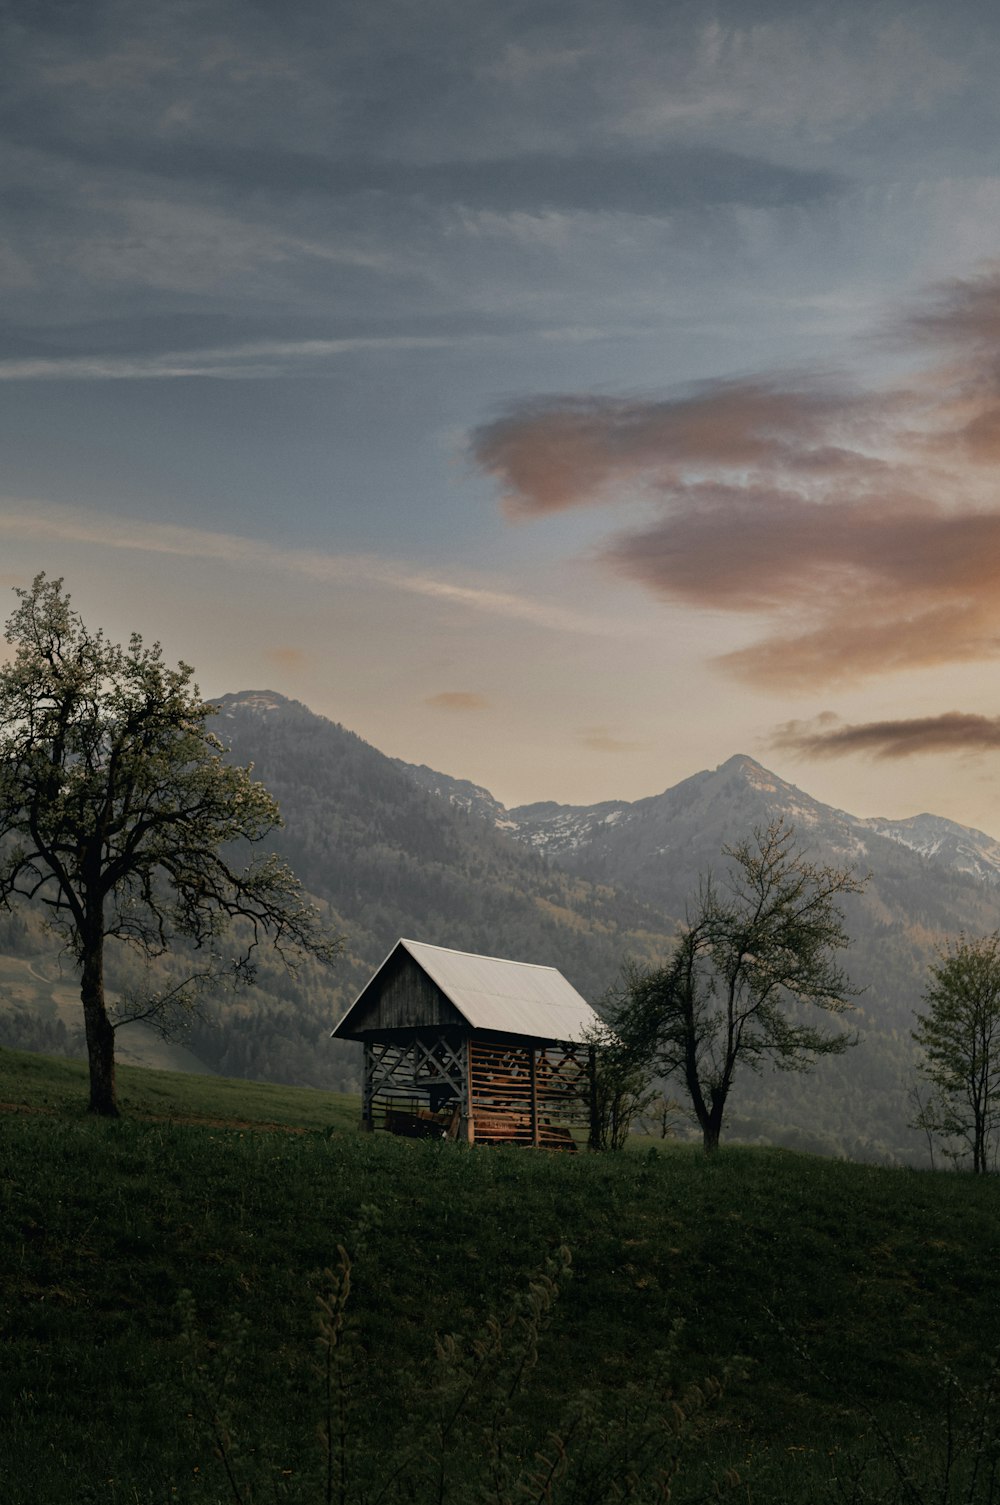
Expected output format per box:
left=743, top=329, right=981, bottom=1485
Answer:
left=399, top=756, right=1000, bottom=1159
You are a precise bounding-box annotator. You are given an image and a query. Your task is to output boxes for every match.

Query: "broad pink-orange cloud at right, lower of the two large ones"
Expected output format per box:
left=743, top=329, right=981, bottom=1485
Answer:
left=604, top=477, right=1000, bottom=689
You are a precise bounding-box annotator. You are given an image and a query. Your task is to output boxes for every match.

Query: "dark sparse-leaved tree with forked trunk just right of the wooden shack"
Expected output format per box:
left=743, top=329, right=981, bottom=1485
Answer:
left=610, top=820, right=866, bottom=1151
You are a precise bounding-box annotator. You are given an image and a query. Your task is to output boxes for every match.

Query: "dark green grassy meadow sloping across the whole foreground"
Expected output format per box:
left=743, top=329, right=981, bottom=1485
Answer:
left=0, top=1052, right=1000, bottom=1505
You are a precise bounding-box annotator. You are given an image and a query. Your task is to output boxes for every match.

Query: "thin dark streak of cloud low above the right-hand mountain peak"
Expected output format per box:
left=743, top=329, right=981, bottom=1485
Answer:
left=770, top=710, right=1000, bottom=759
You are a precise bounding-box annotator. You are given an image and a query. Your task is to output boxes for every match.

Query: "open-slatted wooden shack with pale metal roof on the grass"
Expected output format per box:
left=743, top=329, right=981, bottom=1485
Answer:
left=333, top=941, right=598, bottom=1150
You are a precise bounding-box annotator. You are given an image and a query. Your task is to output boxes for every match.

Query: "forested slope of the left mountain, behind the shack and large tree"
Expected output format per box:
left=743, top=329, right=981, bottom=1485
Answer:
left=0, top=694, right=675, bottom=1090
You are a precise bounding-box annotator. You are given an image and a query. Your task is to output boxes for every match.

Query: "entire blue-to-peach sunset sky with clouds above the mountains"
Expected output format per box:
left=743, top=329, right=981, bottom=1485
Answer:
left=0, top=0, right=1000, bottom=835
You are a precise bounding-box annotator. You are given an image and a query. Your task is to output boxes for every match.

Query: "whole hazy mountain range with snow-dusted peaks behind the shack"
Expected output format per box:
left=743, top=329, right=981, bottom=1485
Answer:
left=0, top=691, right=1000, bottom=1160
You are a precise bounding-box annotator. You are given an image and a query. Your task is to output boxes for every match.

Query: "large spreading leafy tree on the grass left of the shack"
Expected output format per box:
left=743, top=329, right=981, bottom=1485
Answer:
left=0, top=573, right=340, bottom=1115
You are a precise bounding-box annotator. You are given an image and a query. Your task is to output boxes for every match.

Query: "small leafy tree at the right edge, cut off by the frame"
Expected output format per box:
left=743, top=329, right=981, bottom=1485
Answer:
left=913, top=930, right=1000, bottom=1172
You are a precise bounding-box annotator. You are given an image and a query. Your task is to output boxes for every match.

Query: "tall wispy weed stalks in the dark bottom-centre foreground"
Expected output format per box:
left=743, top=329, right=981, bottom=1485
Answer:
left=177, top=1246, right=739, bottom=1505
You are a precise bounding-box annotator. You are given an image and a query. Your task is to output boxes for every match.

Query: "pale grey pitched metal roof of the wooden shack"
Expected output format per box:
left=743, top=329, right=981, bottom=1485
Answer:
left=333, top=941, right=599, bottom=1043
